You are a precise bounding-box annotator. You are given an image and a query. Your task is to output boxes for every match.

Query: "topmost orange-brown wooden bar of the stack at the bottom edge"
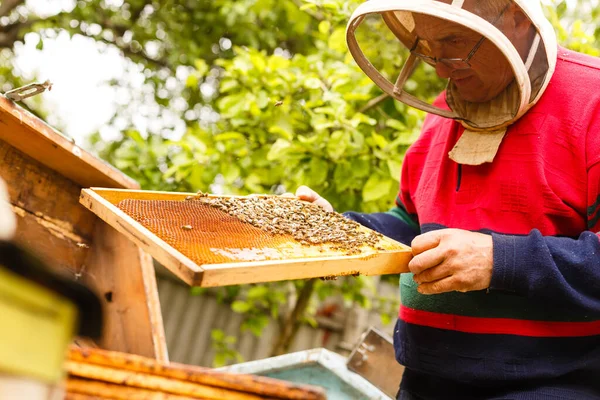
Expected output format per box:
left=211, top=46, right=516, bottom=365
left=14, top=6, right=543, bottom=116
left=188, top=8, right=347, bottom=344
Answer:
left=68, top=346, right=325, bottom=400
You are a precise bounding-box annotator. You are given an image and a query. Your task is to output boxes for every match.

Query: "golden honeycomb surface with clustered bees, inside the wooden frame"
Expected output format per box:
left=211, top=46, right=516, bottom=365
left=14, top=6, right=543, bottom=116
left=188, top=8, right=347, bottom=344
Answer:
left=117, top=196, right=400, bottom=265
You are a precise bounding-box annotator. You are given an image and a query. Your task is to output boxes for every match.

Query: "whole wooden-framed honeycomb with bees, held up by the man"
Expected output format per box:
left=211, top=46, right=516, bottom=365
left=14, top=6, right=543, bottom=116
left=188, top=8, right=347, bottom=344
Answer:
left=80, top=188, right=411, bottom=287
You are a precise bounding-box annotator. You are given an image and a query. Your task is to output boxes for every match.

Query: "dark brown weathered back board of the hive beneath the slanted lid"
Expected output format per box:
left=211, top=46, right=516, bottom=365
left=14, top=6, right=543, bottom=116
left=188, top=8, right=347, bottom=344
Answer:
left=0, top=140, right=98, bottom=274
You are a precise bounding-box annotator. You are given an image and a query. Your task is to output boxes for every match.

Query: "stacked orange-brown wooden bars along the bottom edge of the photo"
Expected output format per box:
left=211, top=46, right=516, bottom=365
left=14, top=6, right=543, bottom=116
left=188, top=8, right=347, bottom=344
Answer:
left=65, top=346, right=325, bottom=400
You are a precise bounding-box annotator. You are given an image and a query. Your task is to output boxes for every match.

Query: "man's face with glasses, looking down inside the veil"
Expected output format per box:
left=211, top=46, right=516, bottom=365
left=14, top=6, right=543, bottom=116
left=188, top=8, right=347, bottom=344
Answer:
left=414, top=14, right=514, bottom=102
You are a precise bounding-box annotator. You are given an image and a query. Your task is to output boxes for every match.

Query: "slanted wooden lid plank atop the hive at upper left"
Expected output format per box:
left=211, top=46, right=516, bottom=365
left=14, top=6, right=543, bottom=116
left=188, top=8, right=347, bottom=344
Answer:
left=0, top=95, right=139, bottom=189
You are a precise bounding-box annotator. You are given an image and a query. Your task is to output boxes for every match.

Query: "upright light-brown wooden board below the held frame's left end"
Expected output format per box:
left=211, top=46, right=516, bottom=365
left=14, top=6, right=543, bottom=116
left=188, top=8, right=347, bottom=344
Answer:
left=82, top=220, right=168, bottom=361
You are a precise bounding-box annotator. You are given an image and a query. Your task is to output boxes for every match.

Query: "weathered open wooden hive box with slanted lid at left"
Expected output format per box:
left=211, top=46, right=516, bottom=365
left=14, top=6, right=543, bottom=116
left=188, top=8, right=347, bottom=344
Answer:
left=0, top=95, right=168, bottom=361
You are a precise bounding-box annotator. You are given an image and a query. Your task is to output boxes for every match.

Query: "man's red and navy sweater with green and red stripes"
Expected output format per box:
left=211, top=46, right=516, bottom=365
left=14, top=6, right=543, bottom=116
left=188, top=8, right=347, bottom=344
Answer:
left=350, top=48, right=600, bottom=398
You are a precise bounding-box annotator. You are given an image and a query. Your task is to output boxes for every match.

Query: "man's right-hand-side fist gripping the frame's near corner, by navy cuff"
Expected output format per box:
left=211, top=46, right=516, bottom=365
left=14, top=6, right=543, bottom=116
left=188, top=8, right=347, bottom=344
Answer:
left=408, top=229, right=494, bottom=294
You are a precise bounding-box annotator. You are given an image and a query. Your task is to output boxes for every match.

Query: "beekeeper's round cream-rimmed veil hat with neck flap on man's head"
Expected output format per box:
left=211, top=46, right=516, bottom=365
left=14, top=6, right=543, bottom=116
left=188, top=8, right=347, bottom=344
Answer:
left=346, top=0, right=557, bottom=165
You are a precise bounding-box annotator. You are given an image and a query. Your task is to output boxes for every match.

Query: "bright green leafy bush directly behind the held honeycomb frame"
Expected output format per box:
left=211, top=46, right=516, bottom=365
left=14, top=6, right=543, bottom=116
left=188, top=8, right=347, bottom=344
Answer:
left=95, top=2, right=422, bottom=211
